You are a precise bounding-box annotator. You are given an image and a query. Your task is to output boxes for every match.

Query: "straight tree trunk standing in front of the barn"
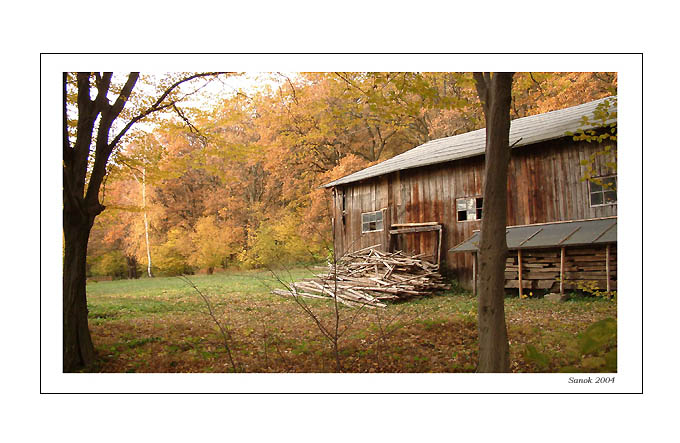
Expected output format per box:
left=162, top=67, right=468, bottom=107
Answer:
left=475, top=73, right=512, bottom=372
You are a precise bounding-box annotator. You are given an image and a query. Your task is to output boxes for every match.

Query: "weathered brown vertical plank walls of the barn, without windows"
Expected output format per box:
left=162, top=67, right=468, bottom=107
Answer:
left=334, top=139, right=616, bottom=284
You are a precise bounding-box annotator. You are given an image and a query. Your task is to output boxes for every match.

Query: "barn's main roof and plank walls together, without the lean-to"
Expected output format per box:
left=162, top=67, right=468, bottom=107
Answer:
left=324, top=97, right=617, bottom=287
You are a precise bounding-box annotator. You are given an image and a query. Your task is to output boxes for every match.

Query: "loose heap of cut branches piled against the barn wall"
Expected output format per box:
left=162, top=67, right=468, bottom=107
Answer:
left=272, top=245, right=450, bottom=308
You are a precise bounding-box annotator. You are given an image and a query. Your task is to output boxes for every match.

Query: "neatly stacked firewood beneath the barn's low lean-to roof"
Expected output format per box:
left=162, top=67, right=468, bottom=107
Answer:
left=505, top=246, right=616, bottom=290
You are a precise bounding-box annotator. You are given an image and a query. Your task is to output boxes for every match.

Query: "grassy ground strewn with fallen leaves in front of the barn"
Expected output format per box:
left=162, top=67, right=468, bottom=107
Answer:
left=87, top=270, right=616, bottom=372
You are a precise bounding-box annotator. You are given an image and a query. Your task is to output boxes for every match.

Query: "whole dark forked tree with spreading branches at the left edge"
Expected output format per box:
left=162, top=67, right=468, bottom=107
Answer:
left=62, top=72, right=219, bottom=372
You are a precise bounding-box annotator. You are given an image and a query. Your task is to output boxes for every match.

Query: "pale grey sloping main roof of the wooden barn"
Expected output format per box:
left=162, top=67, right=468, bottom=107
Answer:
left=323, top=97, right=616, bottom=188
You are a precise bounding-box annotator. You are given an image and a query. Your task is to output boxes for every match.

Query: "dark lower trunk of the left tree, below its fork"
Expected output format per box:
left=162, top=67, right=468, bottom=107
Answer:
left=63, top=206, right=95, bottom=372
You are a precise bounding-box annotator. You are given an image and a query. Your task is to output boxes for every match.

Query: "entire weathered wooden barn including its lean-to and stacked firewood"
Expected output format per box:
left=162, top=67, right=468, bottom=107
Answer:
left=324, top=97, right=617, bottom=289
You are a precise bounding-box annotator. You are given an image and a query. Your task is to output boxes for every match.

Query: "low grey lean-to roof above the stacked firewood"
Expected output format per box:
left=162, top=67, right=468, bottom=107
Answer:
left=449, top=217, right=617, bottom=252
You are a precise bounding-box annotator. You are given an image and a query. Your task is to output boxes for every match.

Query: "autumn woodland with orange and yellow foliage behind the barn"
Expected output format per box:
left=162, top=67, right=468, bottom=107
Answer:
left=88, top=72, right=617, bottom=278
